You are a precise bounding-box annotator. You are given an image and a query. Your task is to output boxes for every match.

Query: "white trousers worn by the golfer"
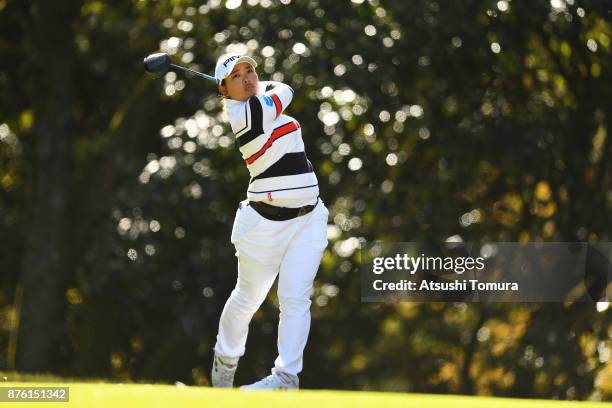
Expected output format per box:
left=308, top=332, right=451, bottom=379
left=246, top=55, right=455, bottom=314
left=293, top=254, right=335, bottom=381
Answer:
left=215, top=200, right=329, bottom=375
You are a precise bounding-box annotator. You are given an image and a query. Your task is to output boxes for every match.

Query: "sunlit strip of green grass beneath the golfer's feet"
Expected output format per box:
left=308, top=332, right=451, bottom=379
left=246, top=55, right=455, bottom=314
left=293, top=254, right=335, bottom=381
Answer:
left=0, top=381, right=612, bottom=408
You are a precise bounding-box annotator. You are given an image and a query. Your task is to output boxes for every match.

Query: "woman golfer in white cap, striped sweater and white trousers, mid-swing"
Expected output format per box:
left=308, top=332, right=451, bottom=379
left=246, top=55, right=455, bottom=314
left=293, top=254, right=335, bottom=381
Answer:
left=211, top=54, right=329, bottom=390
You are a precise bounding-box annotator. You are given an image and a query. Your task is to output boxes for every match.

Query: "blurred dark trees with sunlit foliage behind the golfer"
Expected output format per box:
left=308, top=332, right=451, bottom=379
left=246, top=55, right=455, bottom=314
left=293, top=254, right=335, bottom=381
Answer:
left=0, top=0, right=612, bottom=400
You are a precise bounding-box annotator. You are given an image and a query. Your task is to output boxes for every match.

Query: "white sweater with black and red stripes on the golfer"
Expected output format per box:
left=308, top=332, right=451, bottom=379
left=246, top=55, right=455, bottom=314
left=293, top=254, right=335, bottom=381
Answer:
left=225, top=81, right=319, bottom=207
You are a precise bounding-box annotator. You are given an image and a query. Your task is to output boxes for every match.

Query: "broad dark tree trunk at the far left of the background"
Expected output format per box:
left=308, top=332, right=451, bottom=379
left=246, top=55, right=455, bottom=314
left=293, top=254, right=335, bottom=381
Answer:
left=16, top=0, right=80, bottom=372
